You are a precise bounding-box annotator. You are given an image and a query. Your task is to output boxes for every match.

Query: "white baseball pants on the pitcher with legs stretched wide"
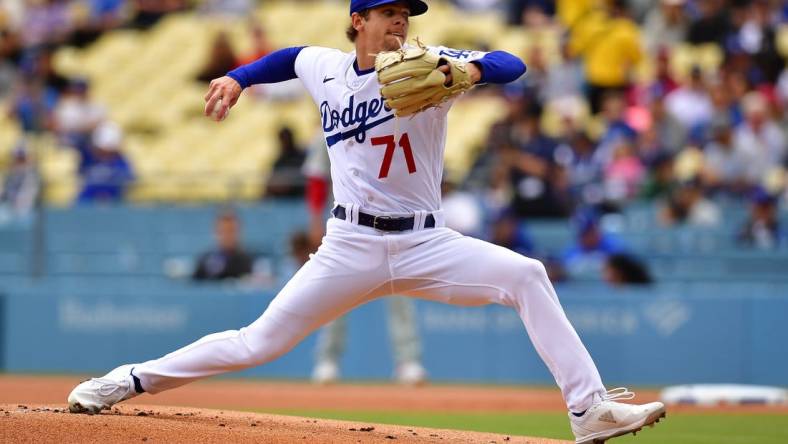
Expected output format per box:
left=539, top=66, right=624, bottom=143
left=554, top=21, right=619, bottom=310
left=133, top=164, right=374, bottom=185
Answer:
left=134, top=219, right=605, bottom=412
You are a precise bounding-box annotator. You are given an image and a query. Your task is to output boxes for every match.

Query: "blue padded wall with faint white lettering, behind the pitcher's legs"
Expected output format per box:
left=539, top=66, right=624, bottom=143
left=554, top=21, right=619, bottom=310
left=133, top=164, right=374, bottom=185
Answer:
left=0, top=281, right=788, bottom=386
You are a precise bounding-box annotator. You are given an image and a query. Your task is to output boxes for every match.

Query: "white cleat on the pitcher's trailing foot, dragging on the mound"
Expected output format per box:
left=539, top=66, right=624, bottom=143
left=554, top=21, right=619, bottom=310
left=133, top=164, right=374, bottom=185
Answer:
left=68, top=364, right=139, bottom=415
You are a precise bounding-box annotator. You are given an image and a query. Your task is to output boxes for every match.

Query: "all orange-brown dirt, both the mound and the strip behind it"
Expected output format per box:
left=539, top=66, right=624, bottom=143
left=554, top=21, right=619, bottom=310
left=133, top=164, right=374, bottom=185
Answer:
left=0, top=375, right=788, bottom=444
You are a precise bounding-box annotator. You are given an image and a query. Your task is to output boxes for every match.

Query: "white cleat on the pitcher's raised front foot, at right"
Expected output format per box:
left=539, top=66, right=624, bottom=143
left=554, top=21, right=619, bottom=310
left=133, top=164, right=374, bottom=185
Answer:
left=569, top=387, right=665, bottom=444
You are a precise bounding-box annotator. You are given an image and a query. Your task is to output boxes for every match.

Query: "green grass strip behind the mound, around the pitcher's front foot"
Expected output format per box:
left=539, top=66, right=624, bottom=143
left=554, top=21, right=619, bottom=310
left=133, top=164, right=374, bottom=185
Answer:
left=258, top=410, right=788, bottom=444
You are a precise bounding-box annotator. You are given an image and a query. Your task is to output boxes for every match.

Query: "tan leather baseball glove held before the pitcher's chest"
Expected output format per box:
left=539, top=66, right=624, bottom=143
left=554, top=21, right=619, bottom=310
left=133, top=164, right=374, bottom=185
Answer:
left=375, top=40, right=473, bottom=117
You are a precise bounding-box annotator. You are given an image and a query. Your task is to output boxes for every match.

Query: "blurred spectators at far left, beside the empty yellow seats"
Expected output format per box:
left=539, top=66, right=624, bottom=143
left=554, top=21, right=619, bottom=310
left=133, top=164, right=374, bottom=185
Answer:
left=0, top=0, right=192, bottom=210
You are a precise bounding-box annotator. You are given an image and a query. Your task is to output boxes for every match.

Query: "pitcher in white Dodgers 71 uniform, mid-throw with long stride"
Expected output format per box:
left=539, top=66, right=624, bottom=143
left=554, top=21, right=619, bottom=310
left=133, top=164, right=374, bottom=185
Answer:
left=68, top=0, right=665, bottom=443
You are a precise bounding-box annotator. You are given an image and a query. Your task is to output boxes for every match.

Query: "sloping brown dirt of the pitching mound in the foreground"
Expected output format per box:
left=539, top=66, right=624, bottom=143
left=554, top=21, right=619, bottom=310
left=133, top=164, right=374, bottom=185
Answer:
left=0, top=404, right=568, bottom=444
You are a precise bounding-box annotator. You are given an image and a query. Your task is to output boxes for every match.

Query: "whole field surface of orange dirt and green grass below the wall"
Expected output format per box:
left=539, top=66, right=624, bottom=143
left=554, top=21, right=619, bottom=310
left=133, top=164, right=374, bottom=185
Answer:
left=0, top=375, right=788, bottom=444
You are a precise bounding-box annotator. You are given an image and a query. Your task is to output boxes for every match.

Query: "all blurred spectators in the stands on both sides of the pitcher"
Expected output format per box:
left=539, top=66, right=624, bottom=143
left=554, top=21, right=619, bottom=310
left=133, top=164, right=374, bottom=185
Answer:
left=0, top=0, right=788, bottom=281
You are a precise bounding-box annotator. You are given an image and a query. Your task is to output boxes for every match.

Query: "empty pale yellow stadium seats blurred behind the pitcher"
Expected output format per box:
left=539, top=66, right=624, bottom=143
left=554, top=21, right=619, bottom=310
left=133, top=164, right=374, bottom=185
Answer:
left=0, top=1, right=740, bottom=205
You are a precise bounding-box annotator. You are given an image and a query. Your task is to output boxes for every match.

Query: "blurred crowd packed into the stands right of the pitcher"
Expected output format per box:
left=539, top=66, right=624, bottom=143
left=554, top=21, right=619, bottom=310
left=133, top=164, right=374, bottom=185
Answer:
left=457, top=0, right=788, bottom=284
